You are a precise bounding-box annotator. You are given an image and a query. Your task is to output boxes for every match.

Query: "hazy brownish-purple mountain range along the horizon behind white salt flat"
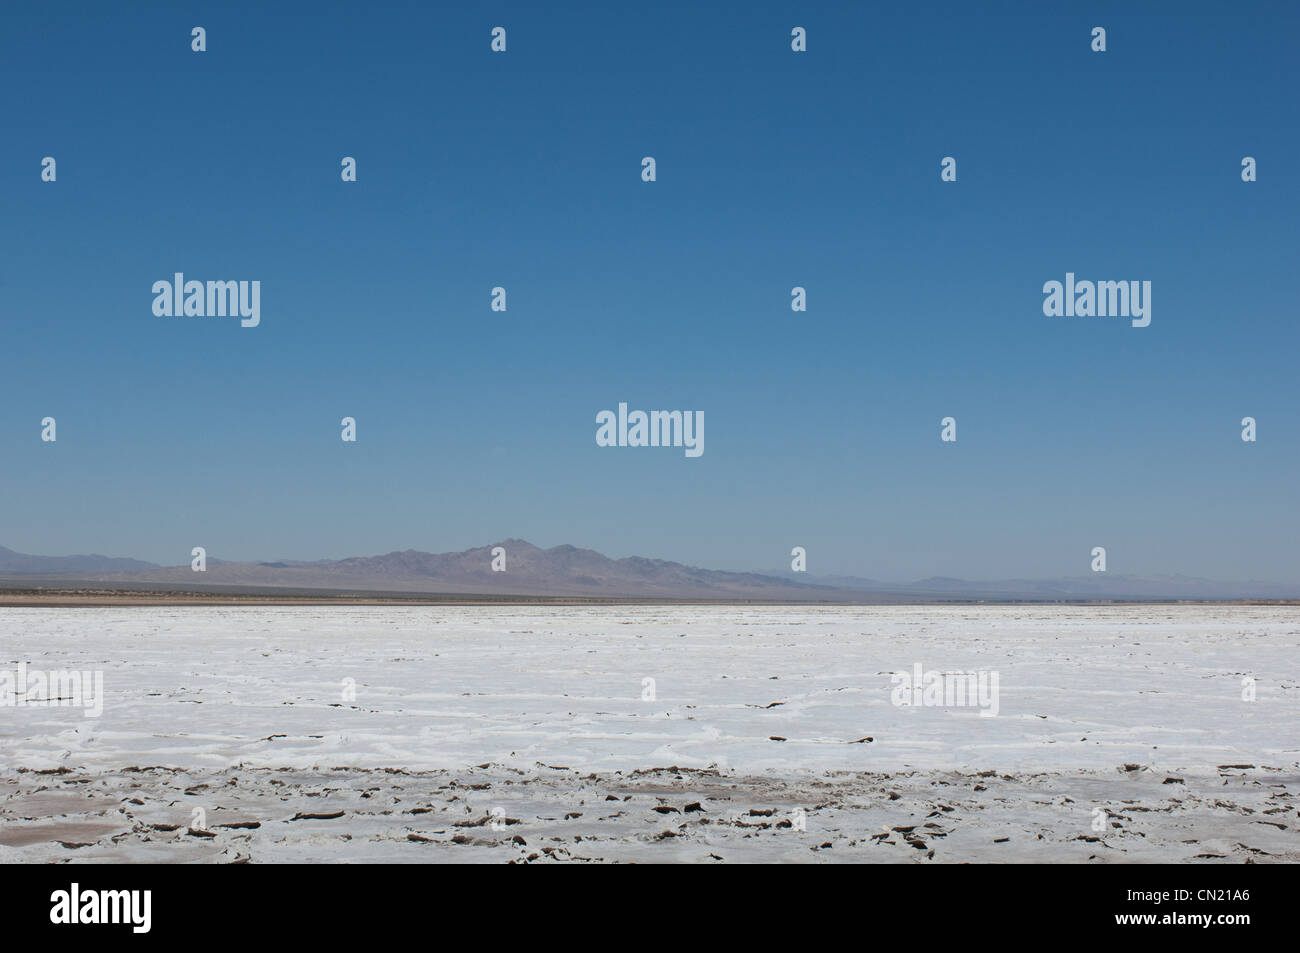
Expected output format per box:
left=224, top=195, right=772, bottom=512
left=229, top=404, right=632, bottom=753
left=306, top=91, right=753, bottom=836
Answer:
left=0, top=540, right=1300, bottom=602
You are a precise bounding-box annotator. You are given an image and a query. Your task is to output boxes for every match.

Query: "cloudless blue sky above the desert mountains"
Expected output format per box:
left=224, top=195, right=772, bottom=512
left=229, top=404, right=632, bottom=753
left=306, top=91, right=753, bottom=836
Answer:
left=0, top=3, right=1300, bottom=581
